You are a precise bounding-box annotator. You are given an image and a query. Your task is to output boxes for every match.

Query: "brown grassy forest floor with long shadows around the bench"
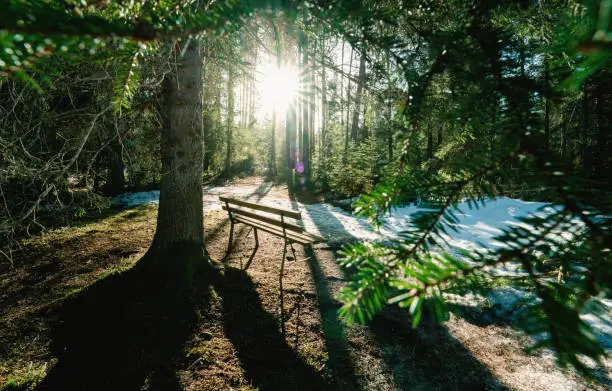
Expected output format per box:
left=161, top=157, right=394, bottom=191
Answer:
left=0, top=178, right=610, bottom=390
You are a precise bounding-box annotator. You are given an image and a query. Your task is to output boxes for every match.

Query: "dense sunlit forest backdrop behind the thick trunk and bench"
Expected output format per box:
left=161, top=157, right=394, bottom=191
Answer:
left=0, top=1, right=611, bottom=239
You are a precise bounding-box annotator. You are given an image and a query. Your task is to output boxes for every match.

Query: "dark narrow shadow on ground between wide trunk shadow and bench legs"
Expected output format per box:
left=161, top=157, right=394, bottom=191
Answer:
left=217, top=267, right=330, bottom=391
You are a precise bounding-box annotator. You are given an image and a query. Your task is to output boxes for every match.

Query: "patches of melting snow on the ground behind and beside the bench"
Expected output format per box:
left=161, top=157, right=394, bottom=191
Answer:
left=113, top=189, right=571, bottom=251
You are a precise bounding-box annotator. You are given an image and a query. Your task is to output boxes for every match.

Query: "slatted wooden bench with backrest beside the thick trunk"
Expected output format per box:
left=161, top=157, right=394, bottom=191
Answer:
left=219, top=197, right=327, bottom=287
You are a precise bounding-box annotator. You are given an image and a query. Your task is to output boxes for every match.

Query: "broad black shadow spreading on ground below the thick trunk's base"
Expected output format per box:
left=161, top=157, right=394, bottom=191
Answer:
left=37, top=246, right=212, bottom=390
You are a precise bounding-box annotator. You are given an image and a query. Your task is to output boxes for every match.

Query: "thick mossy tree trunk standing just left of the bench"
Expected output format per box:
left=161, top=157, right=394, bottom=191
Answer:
left=153, top=40, right=204, bottom=251
